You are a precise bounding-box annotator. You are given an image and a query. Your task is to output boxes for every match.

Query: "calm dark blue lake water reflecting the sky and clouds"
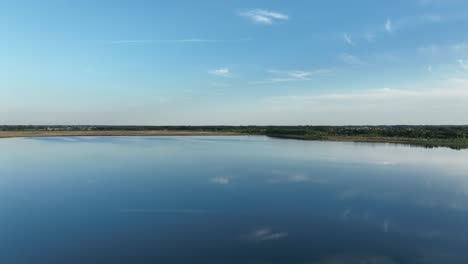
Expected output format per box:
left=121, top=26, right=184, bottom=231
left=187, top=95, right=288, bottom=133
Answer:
left=0, top=137, right=468, bottom=264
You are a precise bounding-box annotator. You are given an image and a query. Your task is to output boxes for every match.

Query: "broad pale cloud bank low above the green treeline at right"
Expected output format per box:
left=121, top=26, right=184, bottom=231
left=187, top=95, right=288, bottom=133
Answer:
left=256, top=79, right=468, bottom=125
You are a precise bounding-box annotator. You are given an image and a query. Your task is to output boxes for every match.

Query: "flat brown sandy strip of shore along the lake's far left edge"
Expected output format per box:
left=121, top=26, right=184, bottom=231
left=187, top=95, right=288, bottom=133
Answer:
left=0, top=130, right=240, bottom=138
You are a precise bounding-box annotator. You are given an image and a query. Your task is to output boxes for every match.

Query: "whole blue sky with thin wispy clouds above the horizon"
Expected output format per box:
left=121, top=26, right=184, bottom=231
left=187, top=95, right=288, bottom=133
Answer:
left=0, top=0, right=468, bottom=125
